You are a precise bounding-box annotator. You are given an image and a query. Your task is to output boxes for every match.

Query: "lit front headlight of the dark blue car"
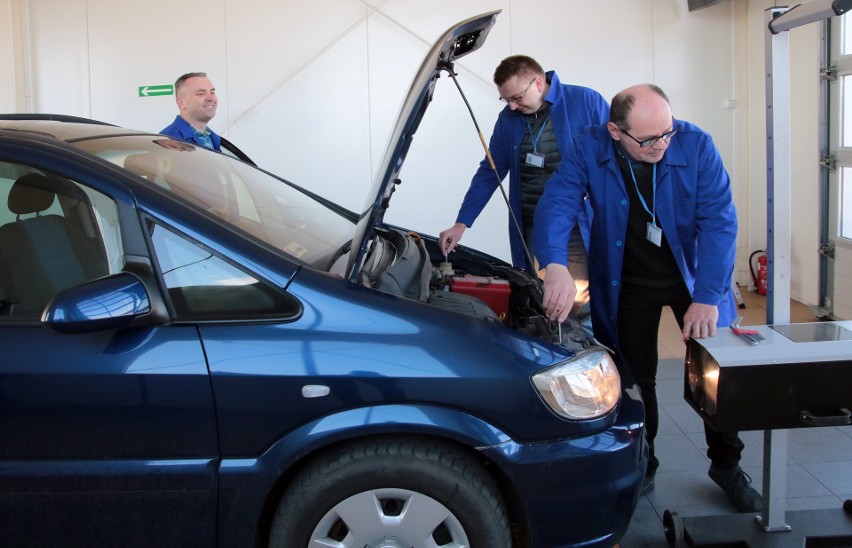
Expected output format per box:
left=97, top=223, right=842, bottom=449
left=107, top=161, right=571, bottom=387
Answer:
left=532, top=348, right=621, bottom=420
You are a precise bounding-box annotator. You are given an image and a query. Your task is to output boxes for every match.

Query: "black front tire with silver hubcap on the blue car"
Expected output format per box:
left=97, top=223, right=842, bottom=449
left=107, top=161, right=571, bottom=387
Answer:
left=269, top=439, right=511, bottom=548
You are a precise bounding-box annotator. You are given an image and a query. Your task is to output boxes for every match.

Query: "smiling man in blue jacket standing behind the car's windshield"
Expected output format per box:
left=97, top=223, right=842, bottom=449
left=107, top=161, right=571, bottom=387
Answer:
left=160, top=72, right=222, bottom=150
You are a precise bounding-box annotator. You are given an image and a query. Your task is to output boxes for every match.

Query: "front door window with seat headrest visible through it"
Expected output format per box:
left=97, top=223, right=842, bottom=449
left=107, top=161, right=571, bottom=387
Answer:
left=0, top=162, right=124, bottom=319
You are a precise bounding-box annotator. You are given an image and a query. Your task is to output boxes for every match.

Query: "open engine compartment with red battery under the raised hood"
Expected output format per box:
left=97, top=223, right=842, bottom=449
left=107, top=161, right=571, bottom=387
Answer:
left=358, top=228, right=596, bottom=352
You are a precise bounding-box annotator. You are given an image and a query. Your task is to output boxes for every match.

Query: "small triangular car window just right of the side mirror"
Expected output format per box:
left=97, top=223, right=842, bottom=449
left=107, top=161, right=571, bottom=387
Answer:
left=151, top=223, right=300, bottom=321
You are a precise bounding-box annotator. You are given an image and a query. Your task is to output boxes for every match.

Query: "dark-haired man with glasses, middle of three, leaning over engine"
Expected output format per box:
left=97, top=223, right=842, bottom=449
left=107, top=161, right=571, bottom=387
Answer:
left=438, top=55, right=609, bottom=329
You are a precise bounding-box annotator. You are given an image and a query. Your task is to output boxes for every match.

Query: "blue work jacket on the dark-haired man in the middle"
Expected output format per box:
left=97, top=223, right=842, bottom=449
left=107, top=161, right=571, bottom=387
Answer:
left=456, top=71, right=609, bottom=270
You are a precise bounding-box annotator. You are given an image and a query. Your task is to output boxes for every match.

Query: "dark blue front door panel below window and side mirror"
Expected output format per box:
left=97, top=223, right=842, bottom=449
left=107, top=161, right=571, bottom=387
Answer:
left=0, top=324, right=218, bottom=546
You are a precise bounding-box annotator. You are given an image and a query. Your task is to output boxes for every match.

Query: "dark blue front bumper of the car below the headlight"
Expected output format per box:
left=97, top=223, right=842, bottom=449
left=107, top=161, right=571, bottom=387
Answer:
left=480, top=389, right=648, bottom=548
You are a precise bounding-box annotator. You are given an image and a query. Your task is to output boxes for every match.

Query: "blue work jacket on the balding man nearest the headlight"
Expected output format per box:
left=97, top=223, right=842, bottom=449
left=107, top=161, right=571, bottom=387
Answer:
left=533, top=122, right=737, bottom=348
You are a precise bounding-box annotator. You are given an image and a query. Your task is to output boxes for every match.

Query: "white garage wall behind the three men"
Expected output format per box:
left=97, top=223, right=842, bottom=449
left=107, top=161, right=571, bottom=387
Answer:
left=0, top=0, right=819, bottom=305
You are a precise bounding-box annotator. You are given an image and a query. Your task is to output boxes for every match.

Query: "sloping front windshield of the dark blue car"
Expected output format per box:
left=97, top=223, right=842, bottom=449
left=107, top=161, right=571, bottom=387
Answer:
left=73, top=135, right=355, bottom=270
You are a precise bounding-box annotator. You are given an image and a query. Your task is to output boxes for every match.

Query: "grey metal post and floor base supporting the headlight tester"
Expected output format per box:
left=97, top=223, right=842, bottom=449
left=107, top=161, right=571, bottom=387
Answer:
left=663, top=0, right=852, bottom=548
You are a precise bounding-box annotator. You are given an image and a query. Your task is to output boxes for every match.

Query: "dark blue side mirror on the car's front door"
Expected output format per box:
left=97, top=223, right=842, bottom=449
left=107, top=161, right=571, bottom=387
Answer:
left=41, top=272, right=159, bottom=333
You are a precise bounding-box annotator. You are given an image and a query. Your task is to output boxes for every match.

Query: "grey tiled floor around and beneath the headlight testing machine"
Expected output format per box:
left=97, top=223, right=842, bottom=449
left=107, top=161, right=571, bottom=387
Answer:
left=621, top=295, right=852, bottom=548
